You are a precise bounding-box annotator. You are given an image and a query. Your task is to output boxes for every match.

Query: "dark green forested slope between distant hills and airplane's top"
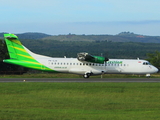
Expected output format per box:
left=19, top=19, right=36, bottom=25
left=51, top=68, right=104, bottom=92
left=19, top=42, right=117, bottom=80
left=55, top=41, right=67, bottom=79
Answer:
left=21, top=40, right=160, bottom=59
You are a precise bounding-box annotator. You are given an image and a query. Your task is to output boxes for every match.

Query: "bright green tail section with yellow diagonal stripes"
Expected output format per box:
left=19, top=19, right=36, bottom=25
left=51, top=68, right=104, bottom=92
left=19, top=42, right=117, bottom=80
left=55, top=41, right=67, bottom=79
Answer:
left=3, top=34, right=51, bottom=71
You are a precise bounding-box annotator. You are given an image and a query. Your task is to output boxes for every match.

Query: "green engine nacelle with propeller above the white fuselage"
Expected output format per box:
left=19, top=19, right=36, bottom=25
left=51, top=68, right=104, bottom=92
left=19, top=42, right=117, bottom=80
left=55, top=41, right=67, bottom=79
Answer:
left=77, top=53, right=108, bottom=64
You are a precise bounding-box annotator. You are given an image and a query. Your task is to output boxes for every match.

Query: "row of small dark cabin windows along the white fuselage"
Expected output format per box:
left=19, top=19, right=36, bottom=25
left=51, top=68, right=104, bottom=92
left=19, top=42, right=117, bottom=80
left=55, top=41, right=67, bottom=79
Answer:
left=52, top=62, right=128, bottom=66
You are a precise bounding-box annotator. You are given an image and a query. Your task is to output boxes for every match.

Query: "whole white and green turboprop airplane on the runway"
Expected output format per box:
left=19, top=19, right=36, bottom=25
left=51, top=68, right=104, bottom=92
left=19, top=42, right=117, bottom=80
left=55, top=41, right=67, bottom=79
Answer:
left=3, top=34, right=158, bottom=78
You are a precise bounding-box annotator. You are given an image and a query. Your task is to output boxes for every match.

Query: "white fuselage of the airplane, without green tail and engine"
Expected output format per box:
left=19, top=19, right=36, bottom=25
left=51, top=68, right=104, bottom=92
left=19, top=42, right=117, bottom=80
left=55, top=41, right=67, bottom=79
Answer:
left=25, top=48, right=158, bottom=75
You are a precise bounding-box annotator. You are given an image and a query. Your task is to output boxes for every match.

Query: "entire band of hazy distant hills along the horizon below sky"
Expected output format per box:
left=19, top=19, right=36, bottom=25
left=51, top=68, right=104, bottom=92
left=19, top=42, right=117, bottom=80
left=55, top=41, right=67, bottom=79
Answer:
left=0, top=32, right=160, bottom=43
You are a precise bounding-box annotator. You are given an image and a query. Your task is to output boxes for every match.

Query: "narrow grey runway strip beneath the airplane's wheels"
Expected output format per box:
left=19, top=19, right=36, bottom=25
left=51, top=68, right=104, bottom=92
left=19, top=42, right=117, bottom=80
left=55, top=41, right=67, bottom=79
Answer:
left=0, top=78, right=160, bottom=83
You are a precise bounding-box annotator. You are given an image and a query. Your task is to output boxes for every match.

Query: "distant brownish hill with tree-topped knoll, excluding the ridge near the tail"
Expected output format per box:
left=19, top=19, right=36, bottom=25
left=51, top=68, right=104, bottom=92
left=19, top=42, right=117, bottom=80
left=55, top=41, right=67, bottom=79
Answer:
left=43, top=32, right=160, bottom=43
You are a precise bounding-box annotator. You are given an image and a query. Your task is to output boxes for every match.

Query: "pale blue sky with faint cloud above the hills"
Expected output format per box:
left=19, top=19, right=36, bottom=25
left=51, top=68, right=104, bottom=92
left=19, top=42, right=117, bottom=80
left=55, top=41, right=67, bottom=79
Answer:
left=0, top=0, right=160, bottom=36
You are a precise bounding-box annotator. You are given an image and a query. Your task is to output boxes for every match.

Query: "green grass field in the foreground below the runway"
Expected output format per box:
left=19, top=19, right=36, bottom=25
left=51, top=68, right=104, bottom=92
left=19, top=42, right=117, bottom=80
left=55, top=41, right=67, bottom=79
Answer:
left=0, top=82, right=160, bottom=120
